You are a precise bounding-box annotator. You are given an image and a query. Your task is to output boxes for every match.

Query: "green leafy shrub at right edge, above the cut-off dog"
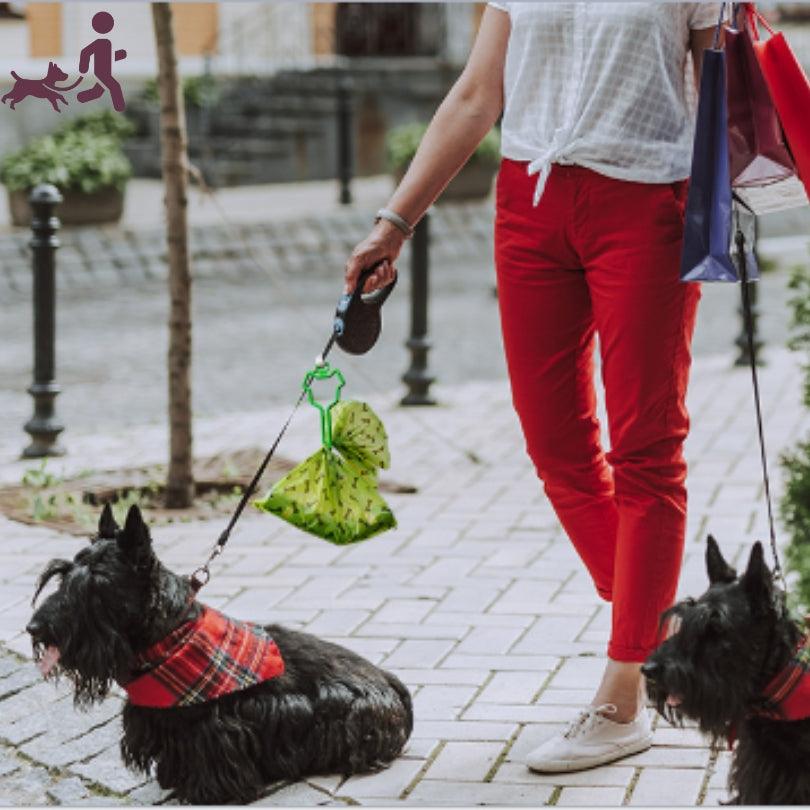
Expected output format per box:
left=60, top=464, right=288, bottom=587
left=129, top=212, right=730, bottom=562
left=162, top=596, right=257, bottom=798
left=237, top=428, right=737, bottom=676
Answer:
left=779, top=256, right=810, bottom=610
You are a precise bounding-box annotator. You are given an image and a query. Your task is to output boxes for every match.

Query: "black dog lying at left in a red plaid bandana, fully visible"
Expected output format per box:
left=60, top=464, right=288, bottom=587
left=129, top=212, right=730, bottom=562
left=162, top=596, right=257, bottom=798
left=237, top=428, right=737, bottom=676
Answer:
left=27, top=506, right=413, bottom=804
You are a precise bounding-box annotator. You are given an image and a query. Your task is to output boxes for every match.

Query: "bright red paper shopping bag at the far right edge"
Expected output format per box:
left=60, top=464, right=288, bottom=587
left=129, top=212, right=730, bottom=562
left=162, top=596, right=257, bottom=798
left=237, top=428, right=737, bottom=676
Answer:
left=746, top=4, right=810, bottom=193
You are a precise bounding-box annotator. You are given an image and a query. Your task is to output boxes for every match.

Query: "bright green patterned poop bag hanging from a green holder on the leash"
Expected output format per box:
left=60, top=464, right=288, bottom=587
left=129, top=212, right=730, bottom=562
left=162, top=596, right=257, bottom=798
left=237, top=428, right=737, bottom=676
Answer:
left=254, top=364, right=397, bottom=545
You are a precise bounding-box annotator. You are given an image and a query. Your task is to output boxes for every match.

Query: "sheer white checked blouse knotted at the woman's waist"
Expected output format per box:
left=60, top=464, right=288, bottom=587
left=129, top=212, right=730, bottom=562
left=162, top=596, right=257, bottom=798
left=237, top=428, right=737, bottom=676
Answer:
left=489, top=2, right=720, bottom=205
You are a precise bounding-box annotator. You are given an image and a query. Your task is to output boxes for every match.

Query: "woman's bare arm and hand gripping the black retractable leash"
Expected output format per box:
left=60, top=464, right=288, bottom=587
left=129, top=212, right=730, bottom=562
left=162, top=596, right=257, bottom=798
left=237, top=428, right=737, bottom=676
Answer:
left=345, top=6, right=510, bottom=292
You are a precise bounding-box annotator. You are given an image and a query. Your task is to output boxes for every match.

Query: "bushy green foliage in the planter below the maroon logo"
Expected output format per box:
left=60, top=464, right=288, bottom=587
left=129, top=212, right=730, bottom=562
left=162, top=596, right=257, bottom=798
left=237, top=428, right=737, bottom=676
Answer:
left=0, top=130, right=132, bottom=194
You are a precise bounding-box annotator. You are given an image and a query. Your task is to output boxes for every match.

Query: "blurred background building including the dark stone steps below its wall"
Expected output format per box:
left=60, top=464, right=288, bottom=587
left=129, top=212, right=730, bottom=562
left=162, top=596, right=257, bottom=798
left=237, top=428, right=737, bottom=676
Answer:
left=0, top=0, right=810, bottom=185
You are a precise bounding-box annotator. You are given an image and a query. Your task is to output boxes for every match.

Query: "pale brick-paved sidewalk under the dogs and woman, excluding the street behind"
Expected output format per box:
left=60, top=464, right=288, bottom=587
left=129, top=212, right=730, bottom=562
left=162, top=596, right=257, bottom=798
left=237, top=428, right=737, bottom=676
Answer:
left=0, top=340, right=808, bottom=806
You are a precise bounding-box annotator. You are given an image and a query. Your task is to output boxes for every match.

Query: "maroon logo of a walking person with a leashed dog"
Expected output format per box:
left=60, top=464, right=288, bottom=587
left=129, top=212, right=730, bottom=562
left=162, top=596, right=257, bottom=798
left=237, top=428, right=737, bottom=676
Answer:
left=0, top=11, right=127, bottom=112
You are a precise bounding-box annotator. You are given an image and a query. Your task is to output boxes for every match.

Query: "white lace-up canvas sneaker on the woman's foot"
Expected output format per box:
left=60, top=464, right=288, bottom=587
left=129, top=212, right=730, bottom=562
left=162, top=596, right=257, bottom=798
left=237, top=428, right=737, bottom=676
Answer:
left=526, top=703, right=653, bottom=773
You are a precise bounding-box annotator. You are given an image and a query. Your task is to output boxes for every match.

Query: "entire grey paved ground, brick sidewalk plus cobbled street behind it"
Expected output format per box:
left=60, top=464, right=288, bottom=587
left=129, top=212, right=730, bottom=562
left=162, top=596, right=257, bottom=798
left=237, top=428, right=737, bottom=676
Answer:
left=0, top=174, right=808, bottom=806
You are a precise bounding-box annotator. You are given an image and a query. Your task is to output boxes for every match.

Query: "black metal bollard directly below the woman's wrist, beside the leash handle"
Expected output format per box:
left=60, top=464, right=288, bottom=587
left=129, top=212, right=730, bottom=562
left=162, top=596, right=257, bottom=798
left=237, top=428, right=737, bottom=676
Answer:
left=400, top=214, right=436, bottom=405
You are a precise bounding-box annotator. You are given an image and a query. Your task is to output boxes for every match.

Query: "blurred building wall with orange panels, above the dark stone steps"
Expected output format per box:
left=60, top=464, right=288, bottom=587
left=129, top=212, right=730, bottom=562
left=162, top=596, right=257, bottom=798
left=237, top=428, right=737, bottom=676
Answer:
left=0, top=0, right=484, bottom=76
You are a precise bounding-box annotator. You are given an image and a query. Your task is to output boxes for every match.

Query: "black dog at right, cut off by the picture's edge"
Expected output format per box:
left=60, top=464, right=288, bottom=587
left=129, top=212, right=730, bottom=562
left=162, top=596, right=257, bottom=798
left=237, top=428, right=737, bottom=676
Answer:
left=642, top=535, right=810, bottom=804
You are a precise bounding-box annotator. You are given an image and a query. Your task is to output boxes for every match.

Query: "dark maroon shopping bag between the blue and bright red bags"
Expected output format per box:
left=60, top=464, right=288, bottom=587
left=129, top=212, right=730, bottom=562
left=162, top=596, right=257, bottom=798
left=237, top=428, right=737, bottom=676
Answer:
left=725, top=6, right=796, bottom=188
